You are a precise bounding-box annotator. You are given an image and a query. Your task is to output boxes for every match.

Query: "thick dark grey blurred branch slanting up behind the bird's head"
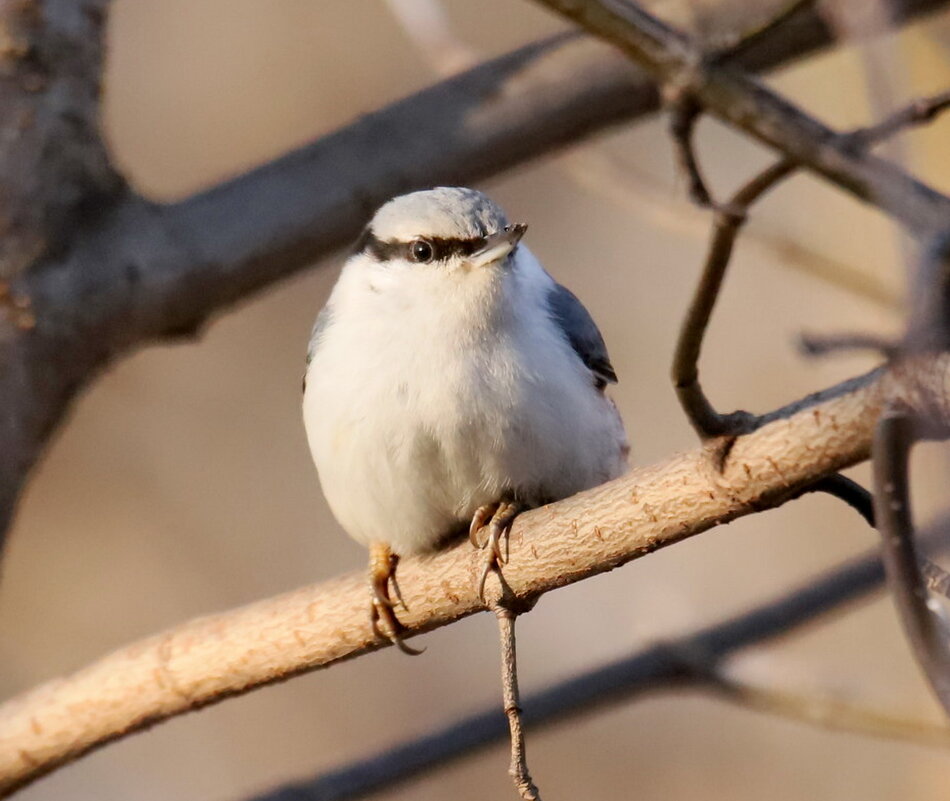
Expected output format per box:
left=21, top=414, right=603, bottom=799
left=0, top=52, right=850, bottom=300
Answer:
left=0, top=0, right=947, bottom=552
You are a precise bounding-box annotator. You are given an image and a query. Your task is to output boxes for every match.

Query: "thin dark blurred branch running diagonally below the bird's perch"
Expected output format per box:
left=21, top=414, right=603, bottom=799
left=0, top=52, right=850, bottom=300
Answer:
left=253, top=520, right=950, bottom=801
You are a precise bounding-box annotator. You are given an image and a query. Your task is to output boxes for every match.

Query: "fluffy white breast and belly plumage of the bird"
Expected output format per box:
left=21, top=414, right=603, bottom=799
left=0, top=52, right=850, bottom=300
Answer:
left=304, top=245, right=627, bottom=554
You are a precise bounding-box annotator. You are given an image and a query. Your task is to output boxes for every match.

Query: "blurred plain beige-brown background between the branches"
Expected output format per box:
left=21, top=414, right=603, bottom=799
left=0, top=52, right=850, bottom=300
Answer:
left=0, top=0, right=950, bottom=801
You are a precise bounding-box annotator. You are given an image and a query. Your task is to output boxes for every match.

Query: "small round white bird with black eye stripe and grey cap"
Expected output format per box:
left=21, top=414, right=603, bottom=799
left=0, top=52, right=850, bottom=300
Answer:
left=303, top=187, right=629, bottom=650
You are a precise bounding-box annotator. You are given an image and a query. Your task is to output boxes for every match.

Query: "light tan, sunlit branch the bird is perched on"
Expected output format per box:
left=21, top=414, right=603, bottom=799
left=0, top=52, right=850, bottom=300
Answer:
left=0, top=356, right=950, bottom=793
